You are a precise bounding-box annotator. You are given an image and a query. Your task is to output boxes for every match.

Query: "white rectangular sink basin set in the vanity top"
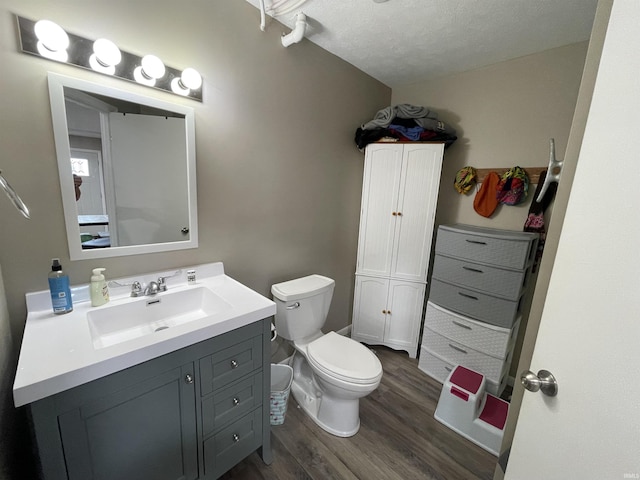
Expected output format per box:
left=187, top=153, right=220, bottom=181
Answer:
left=87, top=287, right=231, bottom=349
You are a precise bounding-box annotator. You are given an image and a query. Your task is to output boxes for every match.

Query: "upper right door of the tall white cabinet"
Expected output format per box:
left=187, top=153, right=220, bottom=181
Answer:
left=391, top=144, right=444, bottom=282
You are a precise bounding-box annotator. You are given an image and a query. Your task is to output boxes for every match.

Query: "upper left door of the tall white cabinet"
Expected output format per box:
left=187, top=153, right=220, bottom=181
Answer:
left=356, top=145, right=402, bottom=275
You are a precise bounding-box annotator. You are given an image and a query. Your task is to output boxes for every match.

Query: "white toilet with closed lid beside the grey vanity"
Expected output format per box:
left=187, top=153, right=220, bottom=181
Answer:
left=271, top=275, right=382, bottom=437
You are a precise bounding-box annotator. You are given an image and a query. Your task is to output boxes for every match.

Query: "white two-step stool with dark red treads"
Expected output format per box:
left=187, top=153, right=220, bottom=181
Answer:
left=434, top=365, right=509, bottom=456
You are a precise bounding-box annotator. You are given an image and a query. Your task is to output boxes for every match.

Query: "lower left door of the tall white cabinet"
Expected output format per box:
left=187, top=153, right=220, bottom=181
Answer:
left=351, top=275, right=389, bottom=343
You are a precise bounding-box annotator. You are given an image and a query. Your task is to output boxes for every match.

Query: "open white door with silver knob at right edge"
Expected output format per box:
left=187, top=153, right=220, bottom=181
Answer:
left=505, top=0, right=640, bottom=480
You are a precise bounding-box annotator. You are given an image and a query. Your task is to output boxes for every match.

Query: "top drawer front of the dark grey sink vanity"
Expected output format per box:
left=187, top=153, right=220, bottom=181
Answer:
left=200, top=335, right=262, bottom=395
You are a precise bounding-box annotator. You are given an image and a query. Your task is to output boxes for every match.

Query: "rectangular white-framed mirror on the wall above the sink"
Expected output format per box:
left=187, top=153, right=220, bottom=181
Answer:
left=48, top=73, right=198, bottom=260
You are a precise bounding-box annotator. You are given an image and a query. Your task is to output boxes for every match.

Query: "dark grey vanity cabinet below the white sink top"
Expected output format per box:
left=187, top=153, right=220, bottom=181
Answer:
left=30, top=319, right=271, bottom=480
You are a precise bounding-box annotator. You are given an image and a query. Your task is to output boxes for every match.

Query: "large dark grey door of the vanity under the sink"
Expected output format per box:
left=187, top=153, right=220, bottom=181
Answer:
left=58, top=363, right=198, bottom=480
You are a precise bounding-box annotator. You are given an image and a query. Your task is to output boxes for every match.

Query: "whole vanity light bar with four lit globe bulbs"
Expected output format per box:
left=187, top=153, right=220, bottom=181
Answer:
left=16, top=15, right=202, bottom=102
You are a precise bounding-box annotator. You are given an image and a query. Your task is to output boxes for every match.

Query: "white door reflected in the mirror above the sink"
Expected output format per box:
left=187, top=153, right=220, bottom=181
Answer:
left=109, top=113, right=189, bottom=246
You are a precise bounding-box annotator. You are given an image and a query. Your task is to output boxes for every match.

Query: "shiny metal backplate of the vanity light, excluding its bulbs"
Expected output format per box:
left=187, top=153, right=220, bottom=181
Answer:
left=16, top=15, right=202, bottom=102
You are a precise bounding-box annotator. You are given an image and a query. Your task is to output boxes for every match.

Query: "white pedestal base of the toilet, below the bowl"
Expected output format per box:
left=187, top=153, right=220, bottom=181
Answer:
left=291, top=379, right=360, bottom=437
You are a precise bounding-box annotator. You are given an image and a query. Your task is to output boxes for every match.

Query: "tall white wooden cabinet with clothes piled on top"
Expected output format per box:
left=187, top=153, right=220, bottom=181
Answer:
left=351, top=143, right=444, bottom=358
